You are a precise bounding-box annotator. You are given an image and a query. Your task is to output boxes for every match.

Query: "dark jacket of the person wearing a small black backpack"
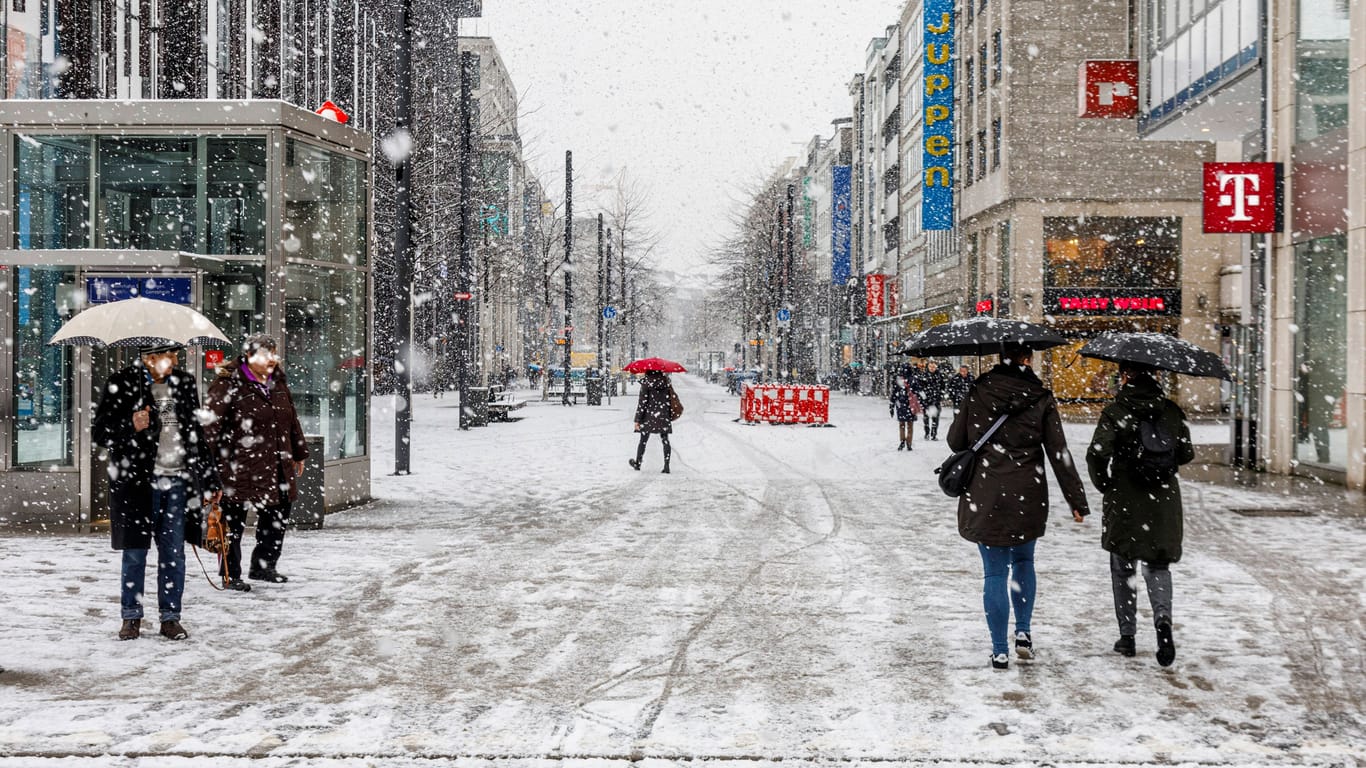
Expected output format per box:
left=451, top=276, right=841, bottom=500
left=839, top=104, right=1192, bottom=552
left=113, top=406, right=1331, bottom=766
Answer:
left=1086, top=376, right=1195, bottom=563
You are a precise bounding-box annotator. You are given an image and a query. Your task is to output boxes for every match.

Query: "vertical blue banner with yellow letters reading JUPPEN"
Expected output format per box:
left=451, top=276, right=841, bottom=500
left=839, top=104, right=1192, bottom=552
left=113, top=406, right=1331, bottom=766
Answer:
left=921, top=0, right=971, bottom=231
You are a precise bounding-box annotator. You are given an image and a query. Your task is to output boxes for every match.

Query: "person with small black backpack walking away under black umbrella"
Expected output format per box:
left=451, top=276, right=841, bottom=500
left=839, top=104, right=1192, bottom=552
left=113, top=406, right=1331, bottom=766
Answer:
left=1086, top=362, right=1195, bottom=667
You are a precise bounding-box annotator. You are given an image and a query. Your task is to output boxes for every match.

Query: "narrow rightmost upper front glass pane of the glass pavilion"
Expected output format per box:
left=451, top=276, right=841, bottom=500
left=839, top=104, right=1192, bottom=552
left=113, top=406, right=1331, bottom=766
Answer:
left=205, top=138, right=266, bottom=256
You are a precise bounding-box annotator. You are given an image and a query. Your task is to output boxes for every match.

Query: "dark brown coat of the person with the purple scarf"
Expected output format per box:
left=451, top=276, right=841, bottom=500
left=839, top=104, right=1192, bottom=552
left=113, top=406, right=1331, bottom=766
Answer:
left=205, top=358, right=309, bottom=506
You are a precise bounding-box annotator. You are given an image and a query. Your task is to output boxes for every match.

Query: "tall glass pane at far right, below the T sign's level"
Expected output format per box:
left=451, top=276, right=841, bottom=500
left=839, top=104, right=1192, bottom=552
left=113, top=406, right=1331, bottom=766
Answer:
left=1295, top=236, right=1348, bottom=466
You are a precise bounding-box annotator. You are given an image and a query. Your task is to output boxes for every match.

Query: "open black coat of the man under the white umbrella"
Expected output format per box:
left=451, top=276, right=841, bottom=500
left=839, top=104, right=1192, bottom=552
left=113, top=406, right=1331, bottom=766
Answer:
left=92, top=362, right=220, bottom=549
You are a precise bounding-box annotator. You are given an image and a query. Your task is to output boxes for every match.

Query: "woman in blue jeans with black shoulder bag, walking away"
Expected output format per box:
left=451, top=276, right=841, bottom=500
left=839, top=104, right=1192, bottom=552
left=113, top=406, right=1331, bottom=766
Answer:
left=948, top=344, right=1090, bottom=670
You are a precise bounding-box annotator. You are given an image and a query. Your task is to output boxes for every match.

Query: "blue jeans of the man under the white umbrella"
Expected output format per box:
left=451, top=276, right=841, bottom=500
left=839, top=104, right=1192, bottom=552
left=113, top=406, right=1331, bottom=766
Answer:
left=119, top=477, right=186, bottom=622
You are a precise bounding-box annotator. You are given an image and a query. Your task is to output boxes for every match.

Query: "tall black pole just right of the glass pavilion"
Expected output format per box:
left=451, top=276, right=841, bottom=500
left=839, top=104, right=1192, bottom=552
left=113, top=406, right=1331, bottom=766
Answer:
left=393, top=0, right=413, bottom=474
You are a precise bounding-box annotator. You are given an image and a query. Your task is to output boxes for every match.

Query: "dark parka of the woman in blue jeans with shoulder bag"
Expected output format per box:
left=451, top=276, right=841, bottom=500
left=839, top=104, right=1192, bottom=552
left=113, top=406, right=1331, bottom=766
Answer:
left=948, top=365, right=1090, bottom=547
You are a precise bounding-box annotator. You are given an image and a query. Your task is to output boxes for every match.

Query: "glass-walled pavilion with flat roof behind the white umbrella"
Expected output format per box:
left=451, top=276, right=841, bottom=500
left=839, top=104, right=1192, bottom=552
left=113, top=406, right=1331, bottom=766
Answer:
left=0, top=101, right=373, bottom=526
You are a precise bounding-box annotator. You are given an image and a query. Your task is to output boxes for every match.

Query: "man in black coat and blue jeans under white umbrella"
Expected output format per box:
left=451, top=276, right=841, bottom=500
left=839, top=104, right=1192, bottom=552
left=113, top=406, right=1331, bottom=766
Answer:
left=92, top=346, right=221, bottom=640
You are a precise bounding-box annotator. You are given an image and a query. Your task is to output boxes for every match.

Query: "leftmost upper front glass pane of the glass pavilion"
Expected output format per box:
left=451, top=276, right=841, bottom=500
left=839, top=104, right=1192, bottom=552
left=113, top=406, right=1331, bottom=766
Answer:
left=15, top=134, right=90, bottom=249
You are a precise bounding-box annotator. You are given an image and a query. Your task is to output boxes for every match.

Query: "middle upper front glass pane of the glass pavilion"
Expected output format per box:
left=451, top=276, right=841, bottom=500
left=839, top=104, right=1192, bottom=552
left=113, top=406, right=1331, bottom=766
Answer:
left=96, top=135, right=198, bottom=253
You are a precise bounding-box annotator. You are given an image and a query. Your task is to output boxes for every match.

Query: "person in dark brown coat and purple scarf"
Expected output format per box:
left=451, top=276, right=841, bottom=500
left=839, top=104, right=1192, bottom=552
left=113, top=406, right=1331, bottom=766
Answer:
left=205, top=333, right=309, bottom=592
